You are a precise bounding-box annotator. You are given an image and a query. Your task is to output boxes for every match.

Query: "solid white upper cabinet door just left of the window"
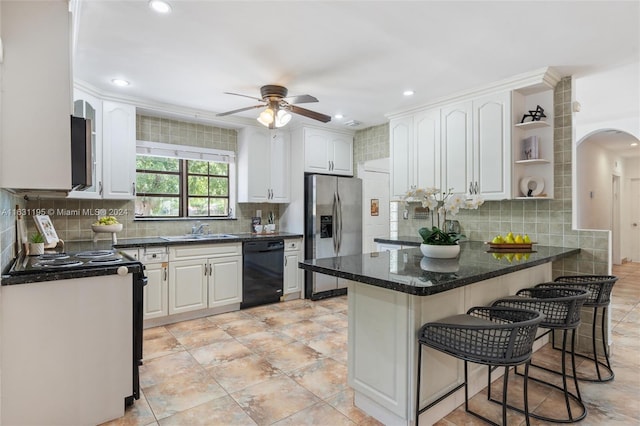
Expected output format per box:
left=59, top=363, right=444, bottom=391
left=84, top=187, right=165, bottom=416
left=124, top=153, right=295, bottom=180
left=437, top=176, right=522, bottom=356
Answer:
left=102, top=101, right=136, bottom=200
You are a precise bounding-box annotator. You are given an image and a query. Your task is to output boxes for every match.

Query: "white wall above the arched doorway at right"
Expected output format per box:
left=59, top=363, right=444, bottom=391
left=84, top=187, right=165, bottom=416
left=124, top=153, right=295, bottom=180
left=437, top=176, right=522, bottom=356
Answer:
left=572, top=58, right=640, bottom=143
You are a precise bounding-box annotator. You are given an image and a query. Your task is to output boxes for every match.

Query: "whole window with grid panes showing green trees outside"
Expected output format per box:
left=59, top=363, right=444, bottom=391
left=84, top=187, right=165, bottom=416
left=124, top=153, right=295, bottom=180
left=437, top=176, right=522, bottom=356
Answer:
left=135, top=141, right=233, bottom=218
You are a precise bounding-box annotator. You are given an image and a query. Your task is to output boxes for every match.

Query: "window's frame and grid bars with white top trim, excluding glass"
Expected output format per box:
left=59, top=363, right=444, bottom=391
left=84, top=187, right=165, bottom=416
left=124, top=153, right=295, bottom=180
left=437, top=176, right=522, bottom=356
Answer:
left=135, top=140, right=236, bottom=220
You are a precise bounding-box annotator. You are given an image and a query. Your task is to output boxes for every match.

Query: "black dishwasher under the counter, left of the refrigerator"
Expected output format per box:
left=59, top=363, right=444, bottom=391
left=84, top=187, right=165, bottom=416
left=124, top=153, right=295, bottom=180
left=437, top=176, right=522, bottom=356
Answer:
left=240, top=240, right=284, bottom=308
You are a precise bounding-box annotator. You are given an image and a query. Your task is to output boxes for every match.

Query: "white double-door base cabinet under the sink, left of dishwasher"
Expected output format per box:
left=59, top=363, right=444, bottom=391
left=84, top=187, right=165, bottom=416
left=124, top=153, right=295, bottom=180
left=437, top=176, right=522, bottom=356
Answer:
left=169, top=243, right=242, bottom=315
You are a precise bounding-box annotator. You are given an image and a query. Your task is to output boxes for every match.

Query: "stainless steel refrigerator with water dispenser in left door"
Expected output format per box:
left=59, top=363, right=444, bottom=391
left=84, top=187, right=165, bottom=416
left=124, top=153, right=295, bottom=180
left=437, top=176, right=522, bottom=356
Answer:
left=305, top=175, right=362, bottom=300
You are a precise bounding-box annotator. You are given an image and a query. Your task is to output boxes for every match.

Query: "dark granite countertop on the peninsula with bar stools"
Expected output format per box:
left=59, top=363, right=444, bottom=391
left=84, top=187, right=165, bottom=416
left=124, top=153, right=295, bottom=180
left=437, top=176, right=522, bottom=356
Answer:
left=299, top=241, right=580, bottom=296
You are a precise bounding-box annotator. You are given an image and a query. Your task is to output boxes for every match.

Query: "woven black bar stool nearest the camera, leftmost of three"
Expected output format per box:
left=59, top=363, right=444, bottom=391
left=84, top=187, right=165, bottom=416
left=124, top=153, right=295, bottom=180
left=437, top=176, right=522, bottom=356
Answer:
left=415, top=306, right=543, bottom=426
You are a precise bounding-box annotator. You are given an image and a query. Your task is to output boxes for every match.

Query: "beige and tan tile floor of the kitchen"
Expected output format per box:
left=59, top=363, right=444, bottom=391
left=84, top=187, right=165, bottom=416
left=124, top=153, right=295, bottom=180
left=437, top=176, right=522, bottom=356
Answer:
left=108, top=263, right=640, bottom=426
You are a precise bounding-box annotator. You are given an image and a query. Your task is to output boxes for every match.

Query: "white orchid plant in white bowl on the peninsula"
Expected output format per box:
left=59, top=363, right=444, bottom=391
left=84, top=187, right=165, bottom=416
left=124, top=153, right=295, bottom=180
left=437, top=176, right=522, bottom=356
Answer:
left=403, top=188, right=484, bottom=259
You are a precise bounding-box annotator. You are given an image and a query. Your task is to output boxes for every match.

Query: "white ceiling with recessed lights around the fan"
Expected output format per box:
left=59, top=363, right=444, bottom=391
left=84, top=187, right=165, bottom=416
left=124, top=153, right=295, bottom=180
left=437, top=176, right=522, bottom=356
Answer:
left=74, top=0, right=640, bottom=129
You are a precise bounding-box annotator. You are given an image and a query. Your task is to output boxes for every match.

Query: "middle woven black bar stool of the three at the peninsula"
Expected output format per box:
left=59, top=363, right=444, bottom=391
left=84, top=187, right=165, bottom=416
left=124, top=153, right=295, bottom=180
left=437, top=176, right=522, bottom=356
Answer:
left=488, top=287, right=588, bottom=423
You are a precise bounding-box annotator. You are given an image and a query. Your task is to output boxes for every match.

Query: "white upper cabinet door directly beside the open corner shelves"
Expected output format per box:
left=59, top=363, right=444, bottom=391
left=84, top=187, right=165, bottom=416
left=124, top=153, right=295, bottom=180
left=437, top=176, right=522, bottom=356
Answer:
left=473, top=92, right=511, bottom=200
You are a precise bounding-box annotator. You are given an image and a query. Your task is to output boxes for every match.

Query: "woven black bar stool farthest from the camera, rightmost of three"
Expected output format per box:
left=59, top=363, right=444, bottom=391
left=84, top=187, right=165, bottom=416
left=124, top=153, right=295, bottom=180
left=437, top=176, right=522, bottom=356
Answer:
left=536, top=275, right=618, bottom=382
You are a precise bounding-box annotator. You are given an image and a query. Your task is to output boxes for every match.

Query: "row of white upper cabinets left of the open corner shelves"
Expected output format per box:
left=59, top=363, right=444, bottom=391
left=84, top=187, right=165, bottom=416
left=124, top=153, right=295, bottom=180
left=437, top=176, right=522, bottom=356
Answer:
left=389, top=91, right=511, bottom=200
